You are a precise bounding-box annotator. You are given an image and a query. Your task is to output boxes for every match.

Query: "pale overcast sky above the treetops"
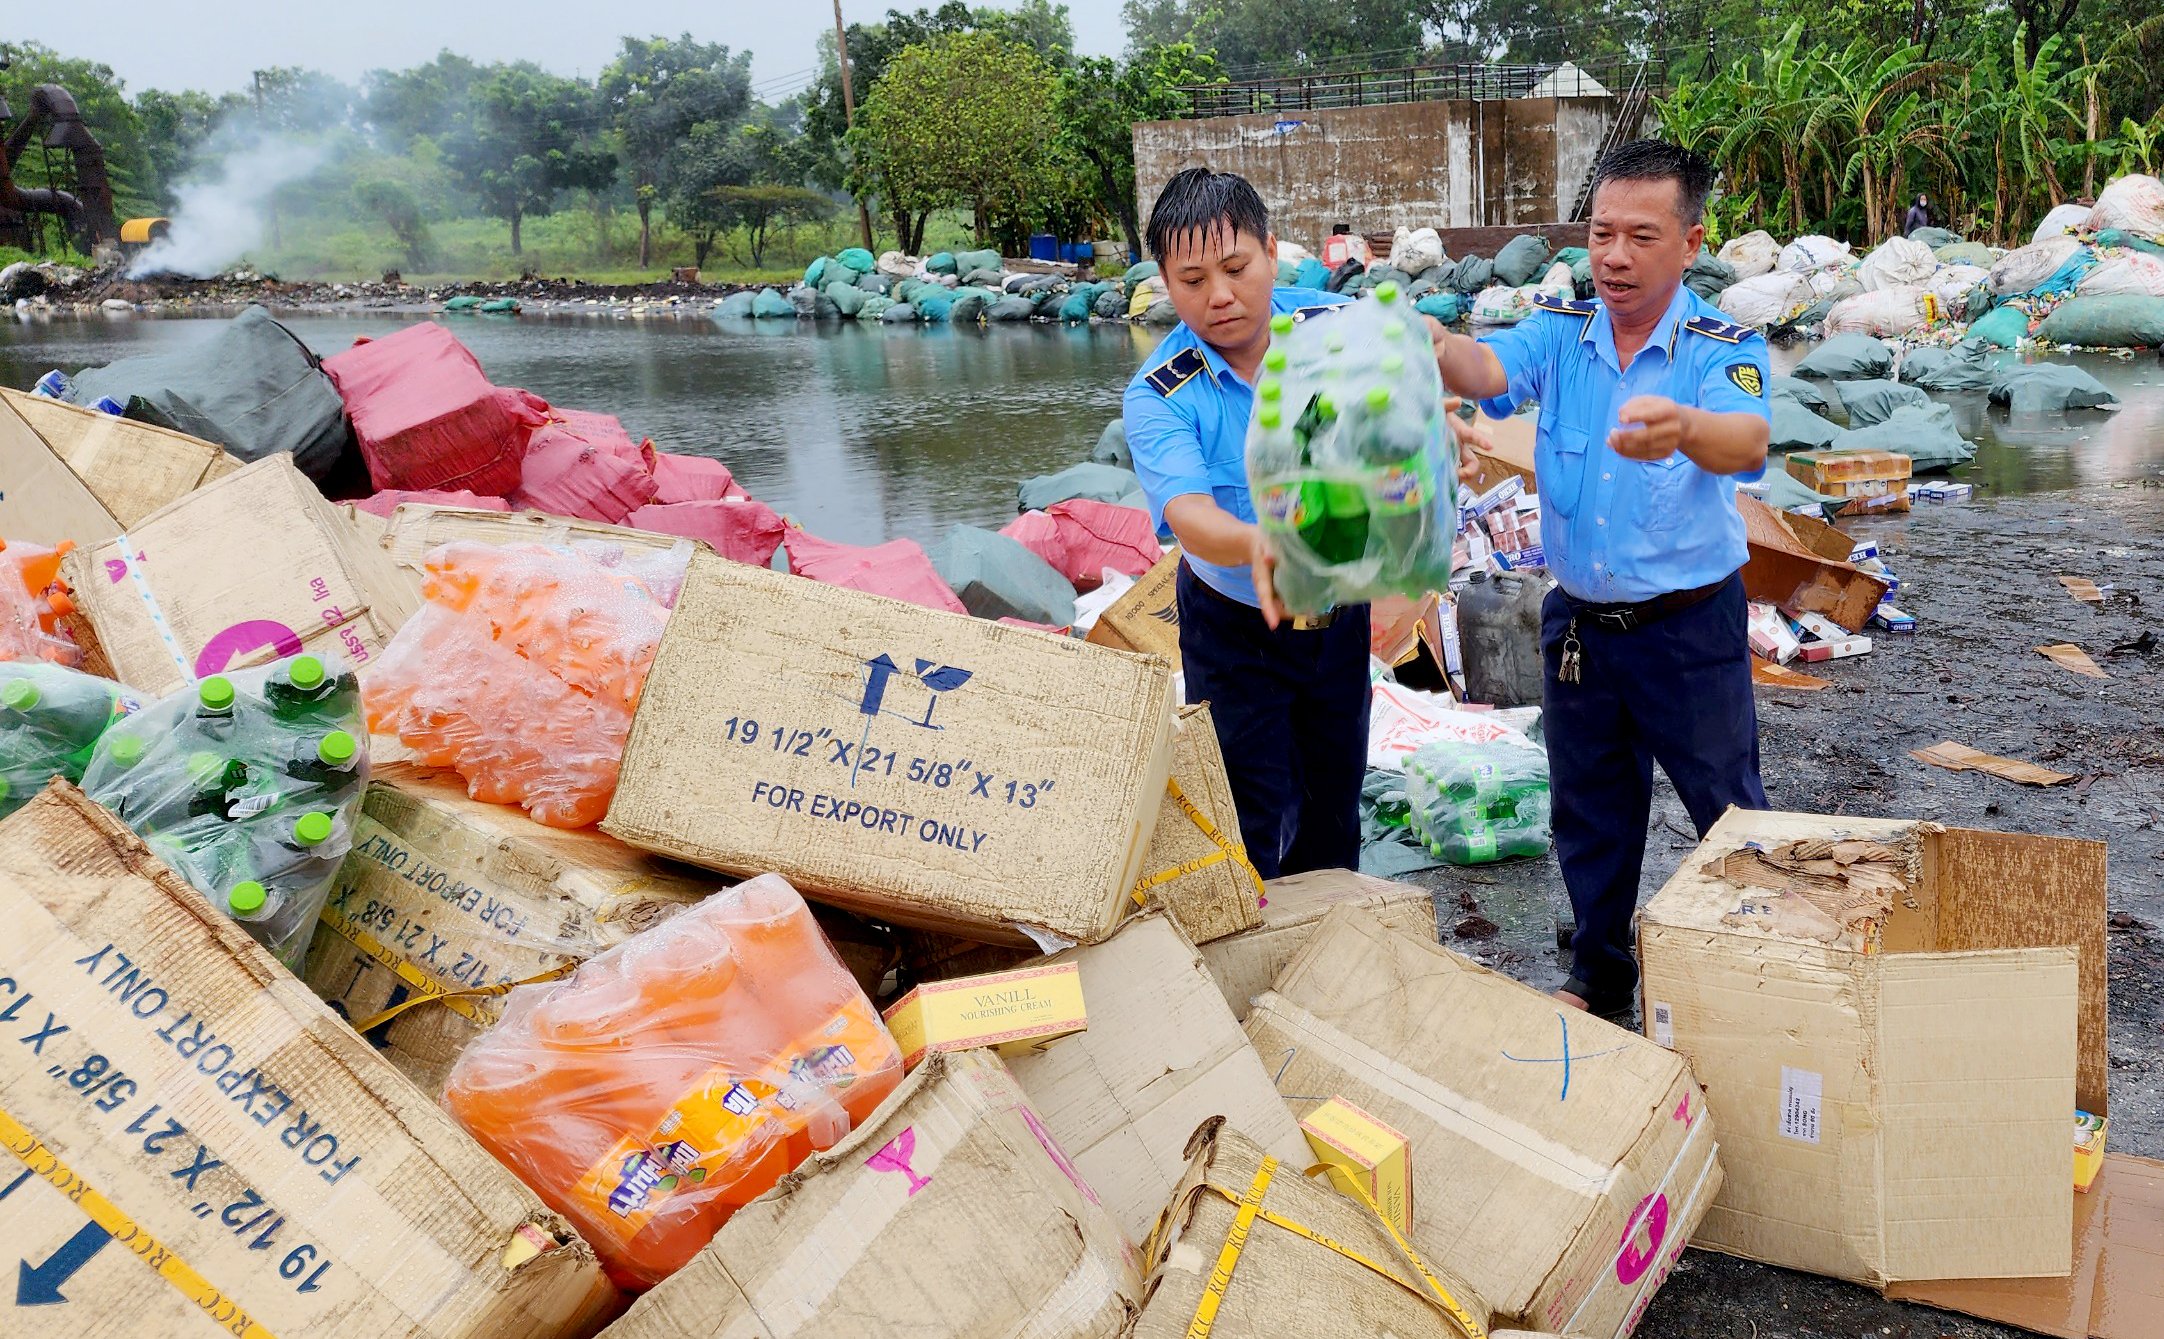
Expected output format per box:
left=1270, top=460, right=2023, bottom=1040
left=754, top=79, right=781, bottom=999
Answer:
left=16, top=0, right=1125, bottom=100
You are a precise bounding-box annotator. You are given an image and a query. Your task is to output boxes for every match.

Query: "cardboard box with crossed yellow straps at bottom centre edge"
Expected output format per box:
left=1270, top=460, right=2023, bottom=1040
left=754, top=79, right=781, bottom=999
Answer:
left=1134, top=1121, right=1489, bottom=1339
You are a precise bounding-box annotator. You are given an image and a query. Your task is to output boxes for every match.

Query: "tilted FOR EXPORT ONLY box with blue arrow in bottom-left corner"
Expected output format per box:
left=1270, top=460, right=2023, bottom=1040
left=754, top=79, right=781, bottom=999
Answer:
left=0, top=781, right=615, bottom=1339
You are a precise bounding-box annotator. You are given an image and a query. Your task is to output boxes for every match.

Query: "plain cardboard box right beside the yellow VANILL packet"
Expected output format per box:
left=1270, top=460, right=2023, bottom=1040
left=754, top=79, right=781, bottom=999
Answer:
left=1008, top=911, right=1307, bottom=1242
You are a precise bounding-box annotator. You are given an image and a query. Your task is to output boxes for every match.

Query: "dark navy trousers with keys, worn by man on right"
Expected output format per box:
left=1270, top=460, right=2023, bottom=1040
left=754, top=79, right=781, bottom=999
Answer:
left=1541, top=575, right=1766, bottom=999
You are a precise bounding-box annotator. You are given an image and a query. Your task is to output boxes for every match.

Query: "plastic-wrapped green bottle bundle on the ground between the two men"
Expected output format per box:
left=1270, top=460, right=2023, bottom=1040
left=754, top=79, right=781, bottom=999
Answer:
left=1404, top=740, right=1549, bottom=865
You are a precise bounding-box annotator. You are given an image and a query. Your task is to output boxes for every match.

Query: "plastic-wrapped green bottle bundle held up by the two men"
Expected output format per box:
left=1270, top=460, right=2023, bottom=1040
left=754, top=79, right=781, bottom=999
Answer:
left=1246, top=283, right=1456, bottom=614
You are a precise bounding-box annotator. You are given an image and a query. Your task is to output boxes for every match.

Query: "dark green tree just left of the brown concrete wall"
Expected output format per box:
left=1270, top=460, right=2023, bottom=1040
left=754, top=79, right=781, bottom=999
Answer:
left=1058, top=41, right=1223, bottom=251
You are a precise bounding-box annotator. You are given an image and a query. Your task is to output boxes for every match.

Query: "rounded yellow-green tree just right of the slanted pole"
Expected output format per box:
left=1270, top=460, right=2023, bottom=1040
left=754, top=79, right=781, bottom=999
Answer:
left=850, top=32, right=1058, bottom=251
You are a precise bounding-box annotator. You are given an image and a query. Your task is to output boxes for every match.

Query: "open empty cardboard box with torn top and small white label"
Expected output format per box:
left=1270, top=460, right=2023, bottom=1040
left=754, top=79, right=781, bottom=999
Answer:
left=1638, top=809, right=2108, bottom=1287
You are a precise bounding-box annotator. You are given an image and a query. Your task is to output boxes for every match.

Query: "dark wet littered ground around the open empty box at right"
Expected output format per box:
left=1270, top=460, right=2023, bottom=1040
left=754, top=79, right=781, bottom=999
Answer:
left=1415, top=480, right=2164, bottom=1339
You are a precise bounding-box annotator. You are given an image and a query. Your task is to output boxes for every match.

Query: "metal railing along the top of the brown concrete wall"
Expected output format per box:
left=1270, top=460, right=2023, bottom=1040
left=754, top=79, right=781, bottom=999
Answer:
left=1182, top=58, right=1660, bottom=119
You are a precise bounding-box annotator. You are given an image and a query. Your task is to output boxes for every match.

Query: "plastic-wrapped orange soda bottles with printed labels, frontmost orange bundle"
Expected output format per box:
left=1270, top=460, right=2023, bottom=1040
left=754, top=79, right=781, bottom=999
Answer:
left=444, top=874, right=902, bottom=1289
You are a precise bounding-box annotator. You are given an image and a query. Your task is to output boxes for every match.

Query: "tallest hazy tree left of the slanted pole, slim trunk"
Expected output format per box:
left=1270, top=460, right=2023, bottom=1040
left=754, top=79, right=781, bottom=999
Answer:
left=599, top=32, right=751, bottom=268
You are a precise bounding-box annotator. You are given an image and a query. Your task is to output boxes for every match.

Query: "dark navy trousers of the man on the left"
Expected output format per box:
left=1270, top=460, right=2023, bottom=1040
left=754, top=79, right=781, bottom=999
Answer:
left=1175, top=562, right=1368, bottom=878
